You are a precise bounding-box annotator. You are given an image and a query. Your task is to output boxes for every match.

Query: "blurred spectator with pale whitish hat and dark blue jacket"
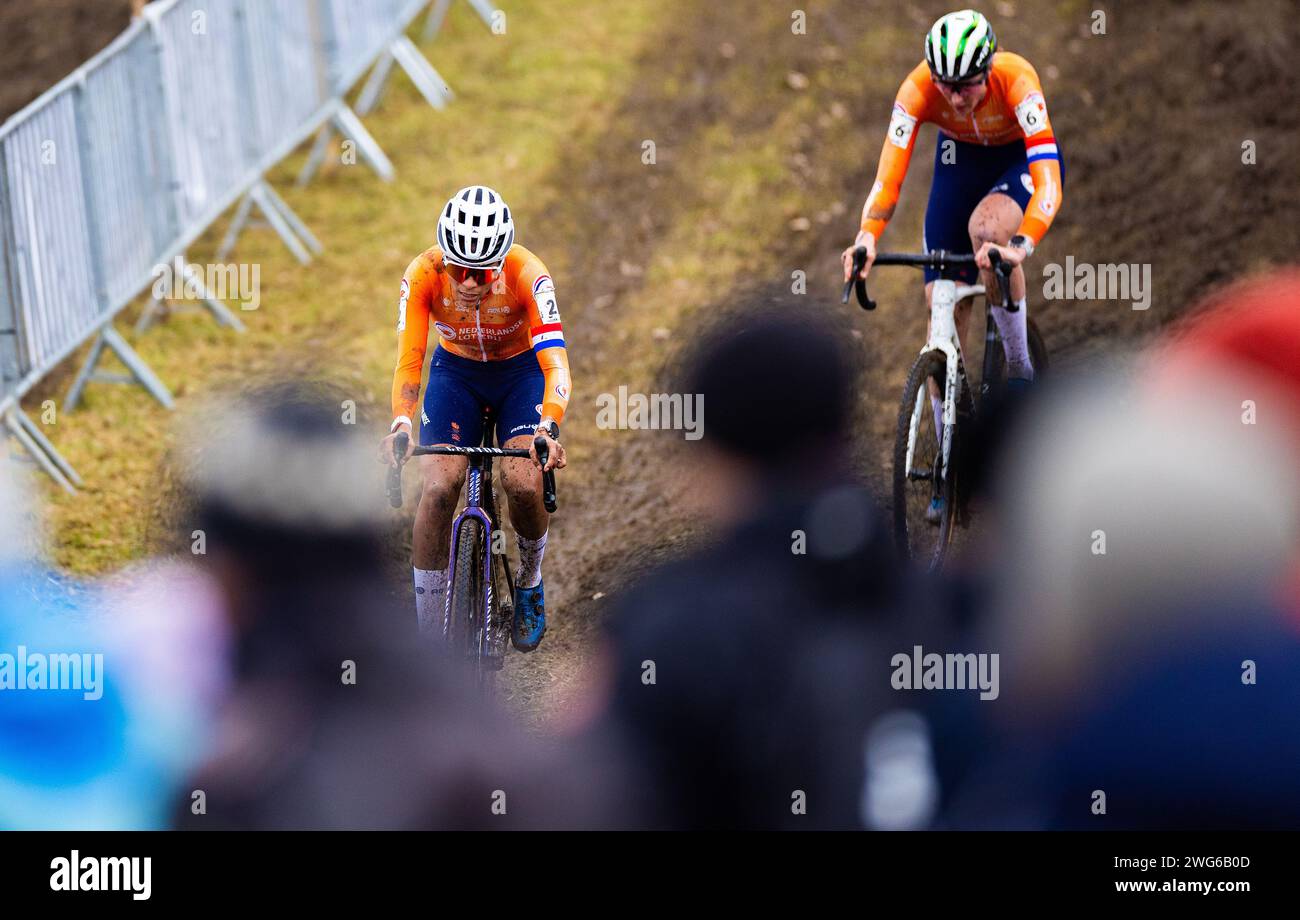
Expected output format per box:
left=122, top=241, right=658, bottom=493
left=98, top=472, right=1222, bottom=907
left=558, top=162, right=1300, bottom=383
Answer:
left=939, top=361, right=1300, bottom=829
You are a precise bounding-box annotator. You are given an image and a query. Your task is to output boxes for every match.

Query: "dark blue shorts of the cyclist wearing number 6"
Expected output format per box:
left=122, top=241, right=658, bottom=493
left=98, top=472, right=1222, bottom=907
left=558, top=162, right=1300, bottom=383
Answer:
left=924, top=131, right=1065, bottom=285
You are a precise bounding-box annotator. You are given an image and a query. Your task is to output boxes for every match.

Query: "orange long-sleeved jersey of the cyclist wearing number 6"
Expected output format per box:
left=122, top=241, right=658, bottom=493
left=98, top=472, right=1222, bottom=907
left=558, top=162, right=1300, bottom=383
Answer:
left=862, top=51, right=1062, bottom=248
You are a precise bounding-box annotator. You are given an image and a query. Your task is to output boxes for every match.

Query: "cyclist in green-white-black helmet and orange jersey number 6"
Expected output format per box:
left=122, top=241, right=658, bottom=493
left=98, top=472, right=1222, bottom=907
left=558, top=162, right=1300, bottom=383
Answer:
left=844, top=9, right=1063, bottom=387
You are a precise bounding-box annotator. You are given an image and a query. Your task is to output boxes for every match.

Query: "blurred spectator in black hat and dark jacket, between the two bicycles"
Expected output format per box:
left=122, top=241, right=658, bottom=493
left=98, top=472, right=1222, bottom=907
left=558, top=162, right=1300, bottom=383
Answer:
left=579, top=313, right=933, bottom=829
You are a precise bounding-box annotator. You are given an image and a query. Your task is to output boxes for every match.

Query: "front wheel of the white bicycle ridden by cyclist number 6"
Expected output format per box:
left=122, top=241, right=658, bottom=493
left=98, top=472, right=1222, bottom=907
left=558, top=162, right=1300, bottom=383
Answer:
left=893, top=351, right=957, bottom=570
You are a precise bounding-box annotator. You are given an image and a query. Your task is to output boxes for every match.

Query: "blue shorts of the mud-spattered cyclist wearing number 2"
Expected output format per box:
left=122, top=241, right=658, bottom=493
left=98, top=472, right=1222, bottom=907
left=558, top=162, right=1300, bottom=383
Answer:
left=420, top=346, right=546, bottom=447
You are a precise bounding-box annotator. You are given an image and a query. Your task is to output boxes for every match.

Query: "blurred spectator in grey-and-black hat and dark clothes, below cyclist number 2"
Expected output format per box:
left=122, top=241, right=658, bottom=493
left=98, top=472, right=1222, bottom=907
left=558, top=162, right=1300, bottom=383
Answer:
left=176, top=385, right=618, bottom=829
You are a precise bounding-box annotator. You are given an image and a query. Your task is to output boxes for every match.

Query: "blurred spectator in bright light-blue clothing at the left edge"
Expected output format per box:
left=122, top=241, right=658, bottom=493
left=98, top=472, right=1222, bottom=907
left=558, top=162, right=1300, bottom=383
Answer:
left=0, top=460, right=176, bottom=830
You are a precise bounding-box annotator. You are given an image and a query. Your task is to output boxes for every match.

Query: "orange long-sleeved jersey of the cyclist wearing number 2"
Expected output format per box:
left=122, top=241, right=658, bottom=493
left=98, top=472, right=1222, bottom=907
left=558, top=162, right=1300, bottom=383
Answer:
left=393, top=244, right=572, bottom=443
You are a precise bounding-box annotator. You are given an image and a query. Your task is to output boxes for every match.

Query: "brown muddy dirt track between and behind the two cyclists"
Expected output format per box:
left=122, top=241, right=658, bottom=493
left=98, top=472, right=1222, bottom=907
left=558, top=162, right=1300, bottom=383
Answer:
left=493, top=1, right=1300, bottom=712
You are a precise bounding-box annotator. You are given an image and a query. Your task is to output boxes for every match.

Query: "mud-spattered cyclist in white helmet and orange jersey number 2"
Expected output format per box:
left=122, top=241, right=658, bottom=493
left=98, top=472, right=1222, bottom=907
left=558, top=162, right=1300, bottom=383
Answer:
left=381, top=186, right=572, bottom=651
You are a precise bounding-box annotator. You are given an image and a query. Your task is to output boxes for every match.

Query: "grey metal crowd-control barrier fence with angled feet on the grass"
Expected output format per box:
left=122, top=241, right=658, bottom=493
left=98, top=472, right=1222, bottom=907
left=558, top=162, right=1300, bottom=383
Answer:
left=0, top=0, right=499, bottom=491
